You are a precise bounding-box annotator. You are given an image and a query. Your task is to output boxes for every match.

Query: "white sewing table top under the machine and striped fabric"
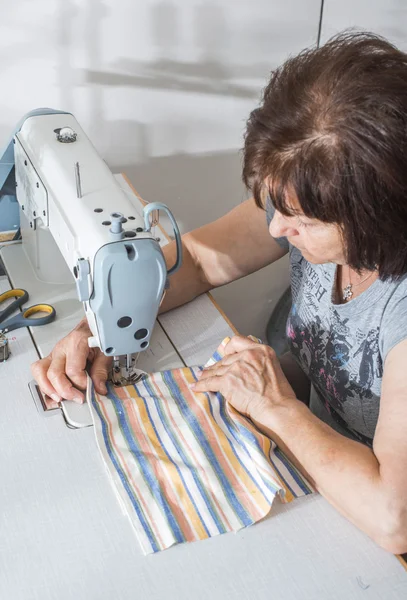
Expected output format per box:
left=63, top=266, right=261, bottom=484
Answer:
left=0, top=180, right=407, bottom=600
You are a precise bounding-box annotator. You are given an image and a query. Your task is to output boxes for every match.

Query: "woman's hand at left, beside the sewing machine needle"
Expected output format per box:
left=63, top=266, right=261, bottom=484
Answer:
left=31, top=319, right=112, bottom=403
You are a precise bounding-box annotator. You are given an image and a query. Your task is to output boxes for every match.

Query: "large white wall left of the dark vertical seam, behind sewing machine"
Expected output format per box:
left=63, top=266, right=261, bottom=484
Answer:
left=0, top=0, right=320, bottom=336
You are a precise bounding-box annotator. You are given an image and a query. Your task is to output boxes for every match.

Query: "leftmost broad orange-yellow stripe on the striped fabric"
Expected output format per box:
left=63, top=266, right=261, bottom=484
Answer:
left=123, top=386, right=204, bottom=542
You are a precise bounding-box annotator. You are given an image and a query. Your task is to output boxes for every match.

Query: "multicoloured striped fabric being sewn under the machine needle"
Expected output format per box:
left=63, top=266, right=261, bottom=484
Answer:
left=88, top=338, right=312, bottom=554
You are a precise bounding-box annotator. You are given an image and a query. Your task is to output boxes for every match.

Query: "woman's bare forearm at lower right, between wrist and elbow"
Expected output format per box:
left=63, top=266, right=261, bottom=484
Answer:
left=252, top=402, right=407, bottom=553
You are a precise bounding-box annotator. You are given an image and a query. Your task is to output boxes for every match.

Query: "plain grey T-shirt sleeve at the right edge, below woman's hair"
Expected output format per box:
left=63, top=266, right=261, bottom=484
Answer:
left=380, top=277, right=407, bottom=362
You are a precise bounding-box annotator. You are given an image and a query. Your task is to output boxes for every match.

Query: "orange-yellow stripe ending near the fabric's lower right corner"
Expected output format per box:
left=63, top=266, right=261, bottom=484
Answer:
left=177, top=368, right=270, bottom=520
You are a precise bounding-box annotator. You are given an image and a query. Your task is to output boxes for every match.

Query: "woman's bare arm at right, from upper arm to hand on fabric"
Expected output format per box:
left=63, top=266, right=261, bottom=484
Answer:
left=195, top=337, right=407, bottom=554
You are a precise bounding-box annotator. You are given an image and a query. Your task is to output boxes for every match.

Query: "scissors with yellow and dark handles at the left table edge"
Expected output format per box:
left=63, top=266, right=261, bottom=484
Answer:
left=0, top=289, right=56, bottom=334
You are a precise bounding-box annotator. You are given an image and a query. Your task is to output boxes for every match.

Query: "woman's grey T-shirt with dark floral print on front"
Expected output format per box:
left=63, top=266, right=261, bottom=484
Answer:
left=267, top=199, right=407, bottom=445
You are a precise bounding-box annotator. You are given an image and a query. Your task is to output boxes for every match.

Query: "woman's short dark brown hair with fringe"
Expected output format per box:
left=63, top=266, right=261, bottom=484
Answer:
left=243, top=31, right=407, bottom=279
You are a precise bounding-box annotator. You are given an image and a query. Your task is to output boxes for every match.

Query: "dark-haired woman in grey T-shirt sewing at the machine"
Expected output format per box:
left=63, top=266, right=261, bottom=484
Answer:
left=33, top=33, right=407, bottom=553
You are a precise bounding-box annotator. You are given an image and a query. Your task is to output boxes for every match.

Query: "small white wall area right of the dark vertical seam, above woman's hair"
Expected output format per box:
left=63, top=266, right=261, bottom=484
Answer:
left=321, top=0, right=407, bottom=51
